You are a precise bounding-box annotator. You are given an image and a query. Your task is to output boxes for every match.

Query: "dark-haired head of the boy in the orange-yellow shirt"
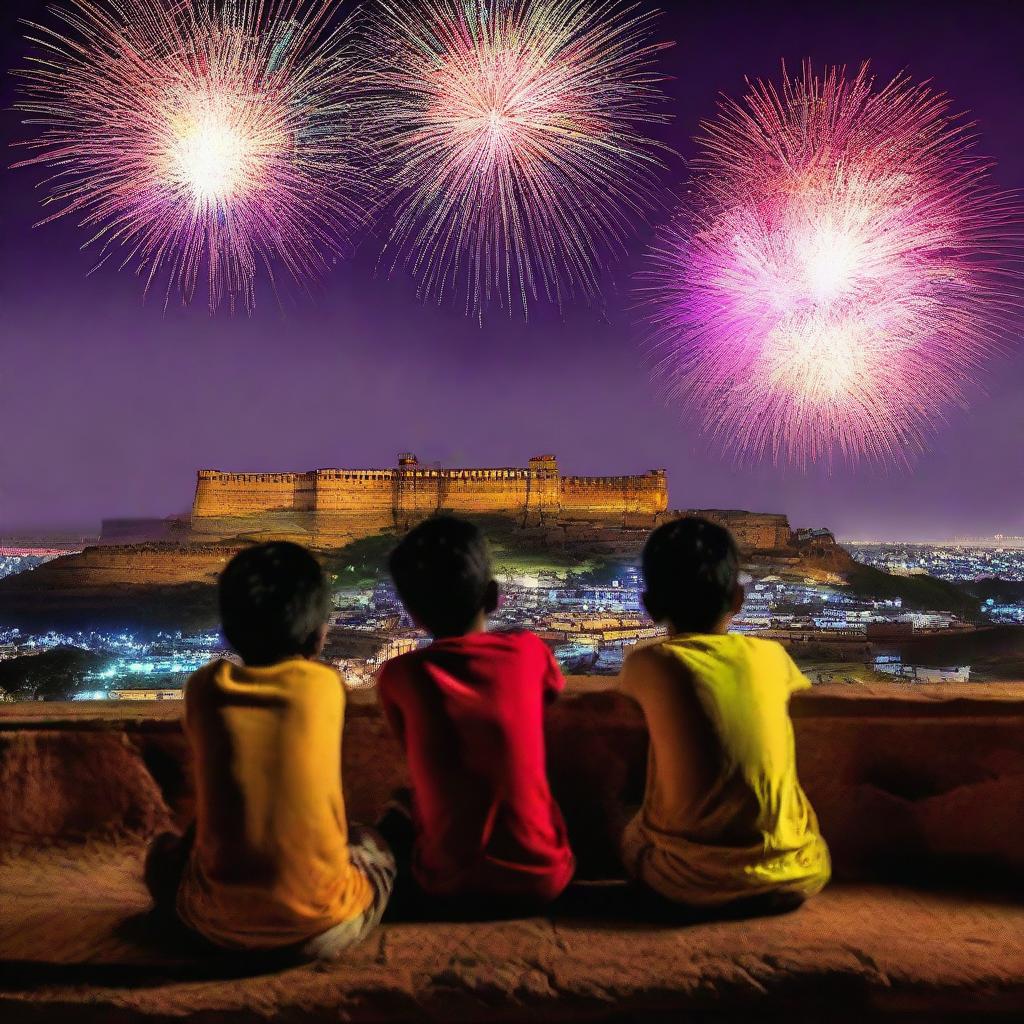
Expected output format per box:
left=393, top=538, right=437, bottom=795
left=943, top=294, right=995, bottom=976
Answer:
left=217, top=541, right=331, bottom=665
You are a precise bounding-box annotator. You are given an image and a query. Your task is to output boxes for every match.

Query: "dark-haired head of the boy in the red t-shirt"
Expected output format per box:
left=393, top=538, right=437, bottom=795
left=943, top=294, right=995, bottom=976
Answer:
left=389, top=515, right=498, bottom=637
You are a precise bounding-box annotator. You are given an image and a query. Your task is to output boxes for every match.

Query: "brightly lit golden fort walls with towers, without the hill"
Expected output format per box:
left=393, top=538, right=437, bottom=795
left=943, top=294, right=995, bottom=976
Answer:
left=193, top=455, right=669, bottom=532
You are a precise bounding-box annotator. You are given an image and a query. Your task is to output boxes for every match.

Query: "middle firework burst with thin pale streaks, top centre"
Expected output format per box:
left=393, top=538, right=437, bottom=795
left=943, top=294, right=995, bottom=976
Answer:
left=375, top=0, right=671, bottom=317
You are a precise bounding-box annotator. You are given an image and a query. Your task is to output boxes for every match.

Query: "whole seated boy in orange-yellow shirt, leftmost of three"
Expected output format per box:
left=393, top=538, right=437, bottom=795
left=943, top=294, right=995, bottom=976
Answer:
left=145, top=543, right=395, bottom=958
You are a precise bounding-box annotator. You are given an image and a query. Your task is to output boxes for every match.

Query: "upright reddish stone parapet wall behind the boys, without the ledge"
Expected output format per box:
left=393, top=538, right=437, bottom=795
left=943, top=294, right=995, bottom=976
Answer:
left=0, top=677, right=1024, bottom=880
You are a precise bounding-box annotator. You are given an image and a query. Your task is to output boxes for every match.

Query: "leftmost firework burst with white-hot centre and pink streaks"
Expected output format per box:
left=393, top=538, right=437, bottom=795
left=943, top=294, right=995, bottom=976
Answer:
left=15, top=0, right=370, bottom=312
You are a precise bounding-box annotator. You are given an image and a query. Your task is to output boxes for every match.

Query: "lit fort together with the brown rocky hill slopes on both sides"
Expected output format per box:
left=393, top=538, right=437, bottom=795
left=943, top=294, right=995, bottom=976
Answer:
left=0, top=455, right=853, bottom=622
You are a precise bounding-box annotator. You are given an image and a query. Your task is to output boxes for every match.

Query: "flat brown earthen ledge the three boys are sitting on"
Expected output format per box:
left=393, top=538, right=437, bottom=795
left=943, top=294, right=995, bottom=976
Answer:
left=0, top=844, right=1024, bottom=1024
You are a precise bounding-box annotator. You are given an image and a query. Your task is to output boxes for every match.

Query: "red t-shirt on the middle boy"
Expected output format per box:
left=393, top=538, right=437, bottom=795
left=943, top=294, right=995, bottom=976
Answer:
left=378, top=633, right=575, bottom=900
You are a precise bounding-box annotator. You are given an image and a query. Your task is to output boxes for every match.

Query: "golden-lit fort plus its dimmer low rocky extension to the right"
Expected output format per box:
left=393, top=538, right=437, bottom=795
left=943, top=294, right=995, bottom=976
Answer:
left=186, top=454, right=834, bottom=556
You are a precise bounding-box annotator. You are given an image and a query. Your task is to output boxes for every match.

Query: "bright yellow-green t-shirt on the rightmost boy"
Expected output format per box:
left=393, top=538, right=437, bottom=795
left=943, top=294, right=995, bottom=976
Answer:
left=621, top=634, right=830, bottom=905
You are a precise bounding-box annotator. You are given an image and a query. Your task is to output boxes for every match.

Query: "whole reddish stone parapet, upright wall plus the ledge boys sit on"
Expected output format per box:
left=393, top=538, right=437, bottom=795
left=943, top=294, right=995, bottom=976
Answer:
left=0, top=678, right=1024, bottom=1024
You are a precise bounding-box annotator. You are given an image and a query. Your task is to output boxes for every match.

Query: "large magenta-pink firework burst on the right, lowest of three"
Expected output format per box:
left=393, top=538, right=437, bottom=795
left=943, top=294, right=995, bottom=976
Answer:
left=643, top=65, right=1019, bottom=465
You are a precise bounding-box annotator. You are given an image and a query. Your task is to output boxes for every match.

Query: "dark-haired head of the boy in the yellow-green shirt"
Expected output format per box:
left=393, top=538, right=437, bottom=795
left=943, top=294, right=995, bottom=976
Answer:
left=643, top=516, right=739, bottom=633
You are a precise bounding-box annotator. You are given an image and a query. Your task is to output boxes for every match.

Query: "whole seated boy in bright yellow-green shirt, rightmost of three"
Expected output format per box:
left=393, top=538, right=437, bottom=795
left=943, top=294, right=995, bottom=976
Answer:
left=620, top=518, right=830, bottom=913
